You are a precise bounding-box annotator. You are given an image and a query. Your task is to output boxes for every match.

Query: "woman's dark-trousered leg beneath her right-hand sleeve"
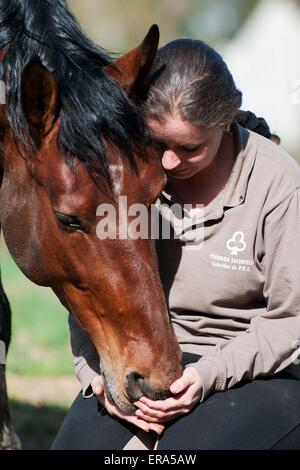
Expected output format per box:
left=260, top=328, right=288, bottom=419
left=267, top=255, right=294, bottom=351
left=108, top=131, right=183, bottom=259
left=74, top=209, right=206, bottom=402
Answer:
left=158, top=374, right=300, bottom=450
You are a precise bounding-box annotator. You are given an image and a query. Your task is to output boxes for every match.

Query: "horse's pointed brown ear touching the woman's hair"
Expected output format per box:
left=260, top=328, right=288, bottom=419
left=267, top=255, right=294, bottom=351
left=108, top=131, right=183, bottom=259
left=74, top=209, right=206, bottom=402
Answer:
left=106, top=24, right=159, bottom=96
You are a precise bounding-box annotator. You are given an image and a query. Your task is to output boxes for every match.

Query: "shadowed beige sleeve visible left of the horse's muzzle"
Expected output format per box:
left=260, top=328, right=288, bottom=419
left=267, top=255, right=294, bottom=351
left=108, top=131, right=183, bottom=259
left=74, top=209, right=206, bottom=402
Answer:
left=69, top=315, right=100, bottom=398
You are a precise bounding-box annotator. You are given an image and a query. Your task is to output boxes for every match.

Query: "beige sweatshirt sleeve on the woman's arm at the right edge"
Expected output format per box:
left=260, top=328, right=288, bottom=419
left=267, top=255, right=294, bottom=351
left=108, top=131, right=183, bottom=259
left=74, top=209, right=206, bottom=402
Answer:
left=189, top=188, right=300, bottom=402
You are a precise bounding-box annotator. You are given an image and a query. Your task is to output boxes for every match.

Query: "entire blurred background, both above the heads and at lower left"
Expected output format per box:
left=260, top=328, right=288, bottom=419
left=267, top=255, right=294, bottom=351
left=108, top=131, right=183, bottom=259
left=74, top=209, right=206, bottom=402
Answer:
left=1, top=0, right=300, bottom=449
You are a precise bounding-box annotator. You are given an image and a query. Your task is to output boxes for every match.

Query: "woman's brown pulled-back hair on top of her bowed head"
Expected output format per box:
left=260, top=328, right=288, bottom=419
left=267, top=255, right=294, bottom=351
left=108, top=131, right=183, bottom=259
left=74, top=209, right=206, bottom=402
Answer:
left=142, top=39, right=242, bottom=129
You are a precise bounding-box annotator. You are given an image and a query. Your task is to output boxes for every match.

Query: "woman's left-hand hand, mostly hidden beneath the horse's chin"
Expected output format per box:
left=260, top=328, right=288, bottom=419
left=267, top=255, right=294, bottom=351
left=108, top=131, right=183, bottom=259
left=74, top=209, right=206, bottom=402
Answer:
left=91, top=375, right=165, bottom=434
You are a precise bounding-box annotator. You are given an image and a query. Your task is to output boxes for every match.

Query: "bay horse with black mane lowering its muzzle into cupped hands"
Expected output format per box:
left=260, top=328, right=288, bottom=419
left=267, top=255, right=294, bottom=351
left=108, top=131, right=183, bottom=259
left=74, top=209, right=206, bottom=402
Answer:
left=0, top=0, right=182, bottom=448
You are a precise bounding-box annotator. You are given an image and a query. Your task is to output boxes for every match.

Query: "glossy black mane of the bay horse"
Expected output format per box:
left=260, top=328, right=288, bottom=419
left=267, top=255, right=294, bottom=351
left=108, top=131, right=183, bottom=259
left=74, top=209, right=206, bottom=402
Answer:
left=0, top=0, right=147, bottom=176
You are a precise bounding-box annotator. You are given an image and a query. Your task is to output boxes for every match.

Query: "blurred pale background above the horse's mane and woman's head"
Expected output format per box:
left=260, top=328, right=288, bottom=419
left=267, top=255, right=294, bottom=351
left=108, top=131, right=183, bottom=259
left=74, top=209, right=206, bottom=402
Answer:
left=69, top=0, right=300, bottom=158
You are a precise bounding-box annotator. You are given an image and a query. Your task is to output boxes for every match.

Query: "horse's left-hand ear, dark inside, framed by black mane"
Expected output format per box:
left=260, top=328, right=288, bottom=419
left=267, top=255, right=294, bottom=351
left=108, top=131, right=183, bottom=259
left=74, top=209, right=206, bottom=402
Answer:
left=21, top=58, right=58, bottom=137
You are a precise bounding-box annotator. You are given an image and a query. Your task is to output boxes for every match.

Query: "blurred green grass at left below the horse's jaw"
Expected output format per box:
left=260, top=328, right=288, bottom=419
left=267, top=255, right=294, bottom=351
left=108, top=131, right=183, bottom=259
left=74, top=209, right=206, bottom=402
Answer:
left=1, top=243, right=73, bottom=376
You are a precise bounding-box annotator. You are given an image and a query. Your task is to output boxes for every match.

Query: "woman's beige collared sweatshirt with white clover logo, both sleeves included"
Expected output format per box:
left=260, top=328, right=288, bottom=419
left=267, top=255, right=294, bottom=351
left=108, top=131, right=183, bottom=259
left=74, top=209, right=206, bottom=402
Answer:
left=70, top=125, right=300, bottom=401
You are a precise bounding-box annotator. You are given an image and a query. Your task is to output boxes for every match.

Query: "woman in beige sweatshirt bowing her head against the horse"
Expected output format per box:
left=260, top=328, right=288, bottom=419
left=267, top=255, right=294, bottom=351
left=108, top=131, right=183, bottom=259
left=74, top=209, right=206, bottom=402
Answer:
left=53, top=40, right=300, bottom=449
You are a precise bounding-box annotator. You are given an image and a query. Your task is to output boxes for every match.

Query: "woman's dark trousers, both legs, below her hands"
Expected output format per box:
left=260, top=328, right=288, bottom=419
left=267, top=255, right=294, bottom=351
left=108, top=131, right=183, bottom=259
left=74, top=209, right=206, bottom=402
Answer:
left=52, top=353, right=300, bottom=450
